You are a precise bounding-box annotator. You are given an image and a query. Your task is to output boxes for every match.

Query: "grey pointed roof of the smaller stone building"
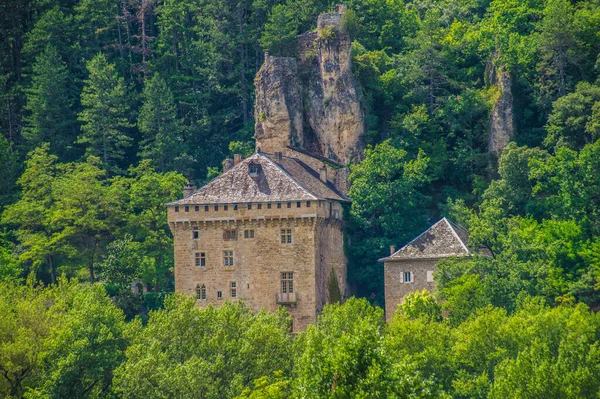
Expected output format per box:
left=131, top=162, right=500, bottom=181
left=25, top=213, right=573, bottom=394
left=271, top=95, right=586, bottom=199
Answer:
left=380, top=218, right=472, bottom=261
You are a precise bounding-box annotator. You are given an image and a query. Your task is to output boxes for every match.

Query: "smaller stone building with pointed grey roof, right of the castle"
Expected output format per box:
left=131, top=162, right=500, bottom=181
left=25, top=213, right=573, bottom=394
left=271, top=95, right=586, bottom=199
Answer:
left=379, top=218, right=472, bottom=319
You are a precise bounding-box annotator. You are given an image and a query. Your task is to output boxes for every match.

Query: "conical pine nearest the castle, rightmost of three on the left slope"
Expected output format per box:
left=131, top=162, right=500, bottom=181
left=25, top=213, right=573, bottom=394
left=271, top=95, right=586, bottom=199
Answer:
left=138, top=74, right=189, bottom=172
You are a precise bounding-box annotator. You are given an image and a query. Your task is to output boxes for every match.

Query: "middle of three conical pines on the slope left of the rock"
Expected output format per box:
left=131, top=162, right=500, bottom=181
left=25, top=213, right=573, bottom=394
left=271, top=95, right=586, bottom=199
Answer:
left=77, top=53, right=132, bottom=172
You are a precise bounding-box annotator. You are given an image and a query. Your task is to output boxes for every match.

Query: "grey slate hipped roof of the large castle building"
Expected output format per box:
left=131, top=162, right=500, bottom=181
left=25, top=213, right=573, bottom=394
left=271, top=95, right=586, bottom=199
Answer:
left=168, top=153, right=349, bottom=205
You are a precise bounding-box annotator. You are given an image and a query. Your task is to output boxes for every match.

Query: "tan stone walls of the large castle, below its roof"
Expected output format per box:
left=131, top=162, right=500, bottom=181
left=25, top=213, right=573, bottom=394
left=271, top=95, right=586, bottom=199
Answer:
left=168, top=201, right=346, bottom=331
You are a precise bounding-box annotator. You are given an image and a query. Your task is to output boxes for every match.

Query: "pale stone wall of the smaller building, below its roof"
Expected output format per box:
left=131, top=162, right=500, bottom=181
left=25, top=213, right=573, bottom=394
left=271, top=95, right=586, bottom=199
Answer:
left=383, top=259, right=435, bottom=320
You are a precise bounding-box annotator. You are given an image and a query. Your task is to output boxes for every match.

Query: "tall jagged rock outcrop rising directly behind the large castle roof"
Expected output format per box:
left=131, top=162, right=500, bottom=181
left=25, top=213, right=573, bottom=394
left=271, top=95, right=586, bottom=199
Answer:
left=255, top=7, right=365, bottom=164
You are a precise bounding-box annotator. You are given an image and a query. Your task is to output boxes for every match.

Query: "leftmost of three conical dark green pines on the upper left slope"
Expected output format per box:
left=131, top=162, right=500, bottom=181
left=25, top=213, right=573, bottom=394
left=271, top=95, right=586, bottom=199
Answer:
left=23, top=45, right=77, bottom=157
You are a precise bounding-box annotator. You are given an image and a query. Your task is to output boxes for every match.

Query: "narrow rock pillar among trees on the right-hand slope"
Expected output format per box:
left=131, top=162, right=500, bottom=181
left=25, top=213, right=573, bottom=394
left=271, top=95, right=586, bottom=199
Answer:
left=488, top=59, right=515, bottom=155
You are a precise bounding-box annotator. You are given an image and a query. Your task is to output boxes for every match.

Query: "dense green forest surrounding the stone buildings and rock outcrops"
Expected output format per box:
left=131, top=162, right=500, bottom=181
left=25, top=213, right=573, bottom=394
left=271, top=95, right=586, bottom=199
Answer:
left=0, top=0, right=600, bottom=398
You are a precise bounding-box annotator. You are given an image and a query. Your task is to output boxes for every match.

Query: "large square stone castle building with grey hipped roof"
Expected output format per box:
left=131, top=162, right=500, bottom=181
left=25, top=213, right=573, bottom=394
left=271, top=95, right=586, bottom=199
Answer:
left=167, top=149, right=349, bottom=331
